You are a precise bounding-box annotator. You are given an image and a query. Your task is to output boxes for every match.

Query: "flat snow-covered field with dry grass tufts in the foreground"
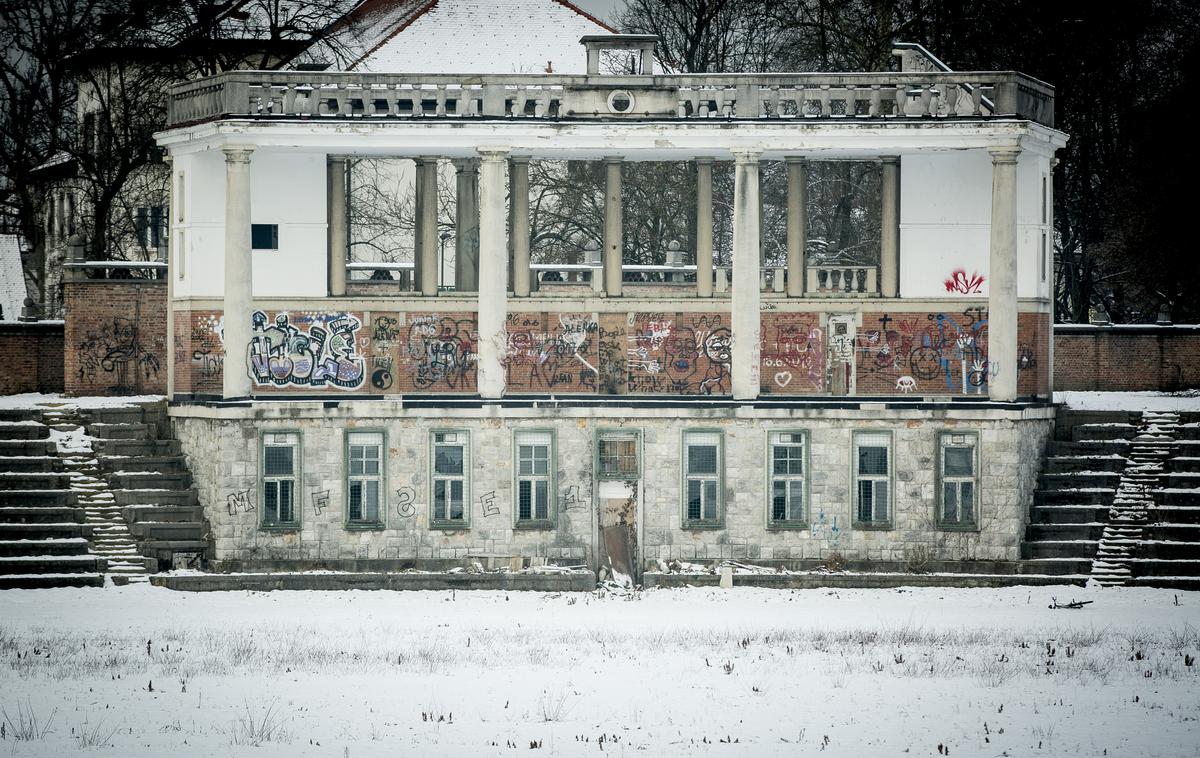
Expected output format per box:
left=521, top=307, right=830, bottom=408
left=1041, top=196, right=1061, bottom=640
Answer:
left=0, top=585, right=1200, bottom=758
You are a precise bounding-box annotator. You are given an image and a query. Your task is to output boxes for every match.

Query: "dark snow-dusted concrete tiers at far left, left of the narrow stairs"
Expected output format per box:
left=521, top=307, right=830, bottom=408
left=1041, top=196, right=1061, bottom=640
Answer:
left=0, top=410, right=106, bottom=589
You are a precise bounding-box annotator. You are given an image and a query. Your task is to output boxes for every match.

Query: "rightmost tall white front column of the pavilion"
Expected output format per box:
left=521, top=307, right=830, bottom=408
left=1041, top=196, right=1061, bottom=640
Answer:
left=988, top=148, right=1021, bottom=401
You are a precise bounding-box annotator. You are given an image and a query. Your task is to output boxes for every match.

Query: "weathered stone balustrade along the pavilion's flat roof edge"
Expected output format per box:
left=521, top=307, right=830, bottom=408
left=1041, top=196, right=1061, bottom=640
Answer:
left=167, top=71, right=1054, bottom=127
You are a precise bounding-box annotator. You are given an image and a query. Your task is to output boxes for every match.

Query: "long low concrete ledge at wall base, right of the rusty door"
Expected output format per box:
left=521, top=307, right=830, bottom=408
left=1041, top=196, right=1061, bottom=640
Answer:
left=642, top=571, right=1091, bottom=590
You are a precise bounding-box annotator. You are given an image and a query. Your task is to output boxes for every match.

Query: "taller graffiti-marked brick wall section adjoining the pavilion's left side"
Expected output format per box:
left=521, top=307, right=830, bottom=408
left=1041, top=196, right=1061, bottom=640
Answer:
left=62, top=279, right=169, bottom=395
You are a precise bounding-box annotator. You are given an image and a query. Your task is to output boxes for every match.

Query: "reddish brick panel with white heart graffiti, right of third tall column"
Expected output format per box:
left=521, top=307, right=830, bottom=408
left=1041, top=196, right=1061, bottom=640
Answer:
left=760, top=313, right=826, bottom=395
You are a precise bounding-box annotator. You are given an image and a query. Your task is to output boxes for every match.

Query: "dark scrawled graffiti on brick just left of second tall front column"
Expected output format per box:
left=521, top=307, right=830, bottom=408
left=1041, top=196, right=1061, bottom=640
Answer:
left=402, top=313, right=476, bottom=392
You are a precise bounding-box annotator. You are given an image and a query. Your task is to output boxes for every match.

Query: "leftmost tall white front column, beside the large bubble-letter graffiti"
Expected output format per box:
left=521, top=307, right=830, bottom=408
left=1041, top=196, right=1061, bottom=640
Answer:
left=221, top=145, right=254, bottom=399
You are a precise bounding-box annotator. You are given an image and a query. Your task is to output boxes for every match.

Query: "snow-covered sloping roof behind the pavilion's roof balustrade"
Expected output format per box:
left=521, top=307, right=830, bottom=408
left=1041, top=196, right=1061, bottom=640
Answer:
left=347, top=0, right=613, bottom=73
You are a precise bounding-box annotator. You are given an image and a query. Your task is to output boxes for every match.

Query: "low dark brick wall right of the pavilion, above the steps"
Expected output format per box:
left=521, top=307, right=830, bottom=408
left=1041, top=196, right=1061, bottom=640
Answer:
left=1054, top=324, right=1200, bottom=391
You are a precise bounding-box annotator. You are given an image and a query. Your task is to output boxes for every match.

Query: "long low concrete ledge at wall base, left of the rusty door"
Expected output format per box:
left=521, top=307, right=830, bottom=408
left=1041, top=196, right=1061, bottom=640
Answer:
left=150, top=571, right=596, bottom=592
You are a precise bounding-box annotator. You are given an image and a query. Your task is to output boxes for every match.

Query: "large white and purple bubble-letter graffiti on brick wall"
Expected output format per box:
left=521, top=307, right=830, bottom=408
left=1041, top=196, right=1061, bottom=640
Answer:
left=247, top=311, right=365, bottom=389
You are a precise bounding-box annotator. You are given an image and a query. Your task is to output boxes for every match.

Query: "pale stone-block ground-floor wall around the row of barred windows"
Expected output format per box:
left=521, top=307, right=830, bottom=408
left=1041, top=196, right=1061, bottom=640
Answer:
left=172, top=401, right=1052, bottom=567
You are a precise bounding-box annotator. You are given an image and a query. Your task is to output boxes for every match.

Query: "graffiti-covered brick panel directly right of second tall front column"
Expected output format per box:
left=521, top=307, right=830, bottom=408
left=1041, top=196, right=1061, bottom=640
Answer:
left=502, top=313, right=599, bottom=392
